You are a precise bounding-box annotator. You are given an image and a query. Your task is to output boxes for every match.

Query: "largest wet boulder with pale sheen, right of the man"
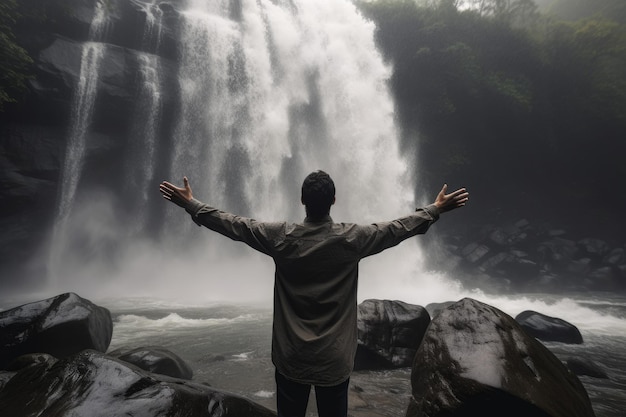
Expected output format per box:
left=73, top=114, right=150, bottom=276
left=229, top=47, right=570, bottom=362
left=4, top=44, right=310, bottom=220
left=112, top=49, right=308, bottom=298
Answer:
left=406, top=298, right=594, bottom=417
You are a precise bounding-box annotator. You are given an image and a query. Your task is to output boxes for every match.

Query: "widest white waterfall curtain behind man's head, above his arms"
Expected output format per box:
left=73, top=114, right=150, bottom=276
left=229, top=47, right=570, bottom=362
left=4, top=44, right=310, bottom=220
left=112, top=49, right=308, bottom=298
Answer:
left=172, top=0, right=412, bottom=221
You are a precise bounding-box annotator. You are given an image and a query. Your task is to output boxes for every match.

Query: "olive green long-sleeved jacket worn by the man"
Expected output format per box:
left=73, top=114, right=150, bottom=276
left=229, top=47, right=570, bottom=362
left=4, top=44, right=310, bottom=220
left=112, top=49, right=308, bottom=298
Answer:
left=186, top=199, right=439, bottom=386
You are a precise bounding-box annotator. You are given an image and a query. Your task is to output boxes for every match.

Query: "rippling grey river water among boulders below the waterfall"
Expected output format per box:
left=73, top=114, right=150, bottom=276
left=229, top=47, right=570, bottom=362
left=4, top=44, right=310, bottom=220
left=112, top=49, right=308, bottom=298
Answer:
left=37, top=293, right=626, bottom=417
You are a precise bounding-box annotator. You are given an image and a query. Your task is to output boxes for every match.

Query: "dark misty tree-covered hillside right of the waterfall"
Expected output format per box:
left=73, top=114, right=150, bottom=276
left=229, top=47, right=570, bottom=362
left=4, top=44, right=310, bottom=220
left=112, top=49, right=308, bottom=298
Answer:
left=359, top=0, right=626, bottom=216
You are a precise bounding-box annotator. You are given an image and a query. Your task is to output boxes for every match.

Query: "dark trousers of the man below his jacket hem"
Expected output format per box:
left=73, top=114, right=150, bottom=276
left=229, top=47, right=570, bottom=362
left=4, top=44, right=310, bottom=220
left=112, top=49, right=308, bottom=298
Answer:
left=276, top=371, right=350, bottom=417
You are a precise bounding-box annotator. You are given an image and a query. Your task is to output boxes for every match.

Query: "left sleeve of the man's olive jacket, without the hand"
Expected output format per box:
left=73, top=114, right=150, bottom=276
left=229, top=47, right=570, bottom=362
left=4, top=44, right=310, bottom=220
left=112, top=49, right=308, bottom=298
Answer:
left=185, top=199, right=285, bottom=256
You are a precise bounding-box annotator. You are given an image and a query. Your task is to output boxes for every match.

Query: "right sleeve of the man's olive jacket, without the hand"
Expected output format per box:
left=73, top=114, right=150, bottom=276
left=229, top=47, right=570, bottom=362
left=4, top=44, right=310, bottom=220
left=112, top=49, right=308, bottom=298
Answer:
left=360, top=204, right=439, bottom=258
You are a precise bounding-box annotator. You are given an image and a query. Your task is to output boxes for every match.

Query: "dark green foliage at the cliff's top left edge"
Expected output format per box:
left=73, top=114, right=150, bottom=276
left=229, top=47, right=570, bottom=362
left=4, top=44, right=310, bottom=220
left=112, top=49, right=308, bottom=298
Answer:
left=0, top=0, right=33, bottom=111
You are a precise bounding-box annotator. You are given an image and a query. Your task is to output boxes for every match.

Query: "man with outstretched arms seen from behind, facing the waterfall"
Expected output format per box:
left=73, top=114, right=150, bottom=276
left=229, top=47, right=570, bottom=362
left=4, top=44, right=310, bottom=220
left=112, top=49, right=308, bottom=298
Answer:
left=159, top=171, right=469, bottom=417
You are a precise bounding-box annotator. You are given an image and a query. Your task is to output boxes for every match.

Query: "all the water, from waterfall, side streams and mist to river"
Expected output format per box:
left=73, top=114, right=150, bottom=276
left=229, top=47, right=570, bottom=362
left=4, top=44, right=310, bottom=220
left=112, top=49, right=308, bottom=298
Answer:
left=30, top=0, right=626, bottom=417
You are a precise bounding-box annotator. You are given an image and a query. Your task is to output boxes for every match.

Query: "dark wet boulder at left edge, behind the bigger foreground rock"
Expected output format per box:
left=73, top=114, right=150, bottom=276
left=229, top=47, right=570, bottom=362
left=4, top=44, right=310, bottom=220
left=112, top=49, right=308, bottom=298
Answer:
left=0, top=293, right=113, bottom=369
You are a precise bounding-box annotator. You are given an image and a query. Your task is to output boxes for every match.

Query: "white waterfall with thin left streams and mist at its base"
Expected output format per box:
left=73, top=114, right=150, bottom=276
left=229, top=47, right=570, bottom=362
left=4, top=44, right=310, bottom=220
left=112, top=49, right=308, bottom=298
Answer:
left=6, top=1, right=460, bottom=303
